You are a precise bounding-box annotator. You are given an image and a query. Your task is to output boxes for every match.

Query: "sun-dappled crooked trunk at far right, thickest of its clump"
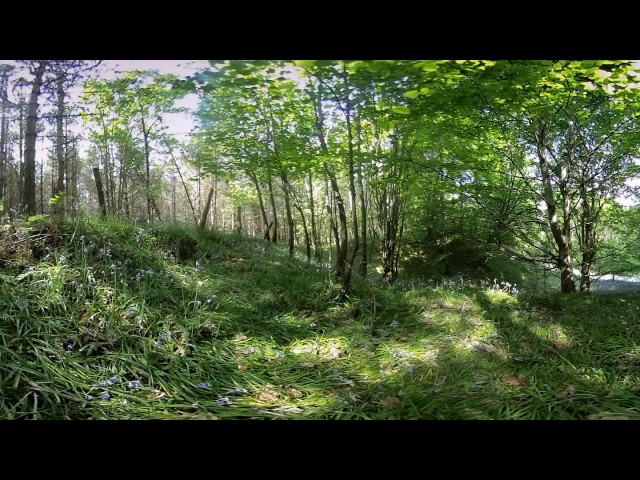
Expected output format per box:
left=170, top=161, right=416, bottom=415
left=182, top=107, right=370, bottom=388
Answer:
left=536, top=120, right=576, bottom=293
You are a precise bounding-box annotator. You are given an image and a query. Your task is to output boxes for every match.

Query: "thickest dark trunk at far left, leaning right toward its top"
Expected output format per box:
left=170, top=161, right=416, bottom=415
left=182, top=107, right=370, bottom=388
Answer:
left=22, top=60, right=50, bottom=215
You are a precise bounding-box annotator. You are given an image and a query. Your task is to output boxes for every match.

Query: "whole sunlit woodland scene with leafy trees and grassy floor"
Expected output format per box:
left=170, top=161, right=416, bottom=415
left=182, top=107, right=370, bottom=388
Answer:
left=0, top=60, right=640, bottom=420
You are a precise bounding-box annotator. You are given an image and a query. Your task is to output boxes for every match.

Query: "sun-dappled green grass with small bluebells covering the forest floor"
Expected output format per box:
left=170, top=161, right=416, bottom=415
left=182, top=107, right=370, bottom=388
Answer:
left=0, top=219, right=640, bottom=420
